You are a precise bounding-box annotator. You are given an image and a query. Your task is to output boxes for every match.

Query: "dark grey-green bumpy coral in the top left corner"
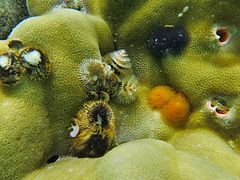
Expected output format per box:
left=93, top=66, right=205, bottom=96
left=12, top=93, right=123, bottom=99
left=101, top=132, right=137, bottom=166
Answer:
left=0, top=0, right=28, bottom=39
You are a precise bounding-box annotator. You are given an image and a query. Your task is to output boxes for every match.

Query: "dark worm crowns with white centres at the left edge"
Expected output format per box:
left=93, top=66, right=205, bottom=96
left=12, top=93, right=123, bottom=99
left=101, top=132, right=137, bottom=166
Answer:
left=0, top=40, right=50, bottom=84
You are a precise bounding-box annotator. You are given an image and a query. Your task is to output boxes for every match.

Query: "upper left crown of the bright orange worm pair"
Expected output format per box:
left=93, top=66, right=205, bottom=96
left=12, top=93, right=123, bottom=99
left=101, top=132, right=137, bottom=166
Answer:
left=148, top=85, right=175, bottom=109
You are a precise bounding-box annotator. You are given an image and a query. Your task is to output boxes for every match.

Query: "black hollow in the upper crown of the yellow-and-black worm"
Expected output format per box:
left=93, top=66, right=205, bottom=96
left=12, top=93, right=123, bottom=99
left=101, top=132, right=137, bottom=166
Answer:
left=91, top=104, right=109, bottom=127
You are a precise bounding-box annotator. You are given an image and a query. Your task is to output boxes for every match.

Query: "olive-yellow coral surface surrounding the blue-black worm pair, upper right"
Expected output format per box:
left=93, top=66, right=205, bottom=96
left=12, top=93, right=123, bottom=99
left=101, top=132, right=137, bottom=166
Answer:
left=88, top=0, right=240, bottom=107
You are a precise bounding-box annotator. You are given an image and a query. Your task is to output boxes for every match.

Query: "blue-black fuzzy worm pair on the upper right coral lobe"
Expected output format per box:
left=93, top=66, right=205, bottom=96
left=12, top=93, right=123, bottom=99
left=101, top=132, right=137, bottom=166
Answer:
left=147, top=25, right=189, bottom=57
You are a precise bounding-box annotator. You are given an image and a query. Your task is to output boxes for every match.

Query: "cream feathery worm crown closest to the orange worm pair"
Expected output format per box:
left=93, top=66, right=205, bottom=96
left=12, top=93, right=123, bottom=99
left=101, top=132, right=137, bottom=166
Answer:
left=114, top=75, right=139, bottom=104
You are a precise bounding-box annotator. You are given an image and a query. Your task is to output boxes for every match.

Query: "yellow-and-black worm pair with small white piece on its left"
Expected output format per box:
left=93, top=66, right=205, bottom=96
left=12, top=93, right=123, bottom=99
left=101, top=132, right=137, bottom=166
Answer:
left=70, top=101, right=115, bottom=157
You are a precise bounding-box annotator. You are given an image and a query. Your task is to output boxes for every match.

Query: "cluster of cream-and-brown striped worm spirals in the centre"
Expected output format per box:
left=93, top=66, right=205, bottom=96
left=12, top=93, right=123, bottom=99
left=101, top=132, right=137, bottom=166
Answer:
left=78, top=49, right=139, bottom=104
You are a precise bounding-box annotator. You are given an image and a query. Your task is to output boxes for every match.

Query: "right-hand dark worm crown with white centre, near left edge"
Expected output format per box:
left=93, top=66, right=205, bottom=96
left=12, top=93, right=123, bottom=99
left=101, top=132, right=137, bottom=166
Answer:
left=20, top=47, right=51, bottom=80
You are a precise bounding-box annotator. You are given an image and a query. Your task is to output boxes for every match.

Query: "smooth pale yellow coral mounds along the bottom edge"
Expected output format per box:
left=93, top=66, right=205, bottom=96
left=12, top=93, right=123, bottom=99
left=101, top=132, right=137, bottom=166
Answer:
left=25, top=138, right=239, bottom=179
